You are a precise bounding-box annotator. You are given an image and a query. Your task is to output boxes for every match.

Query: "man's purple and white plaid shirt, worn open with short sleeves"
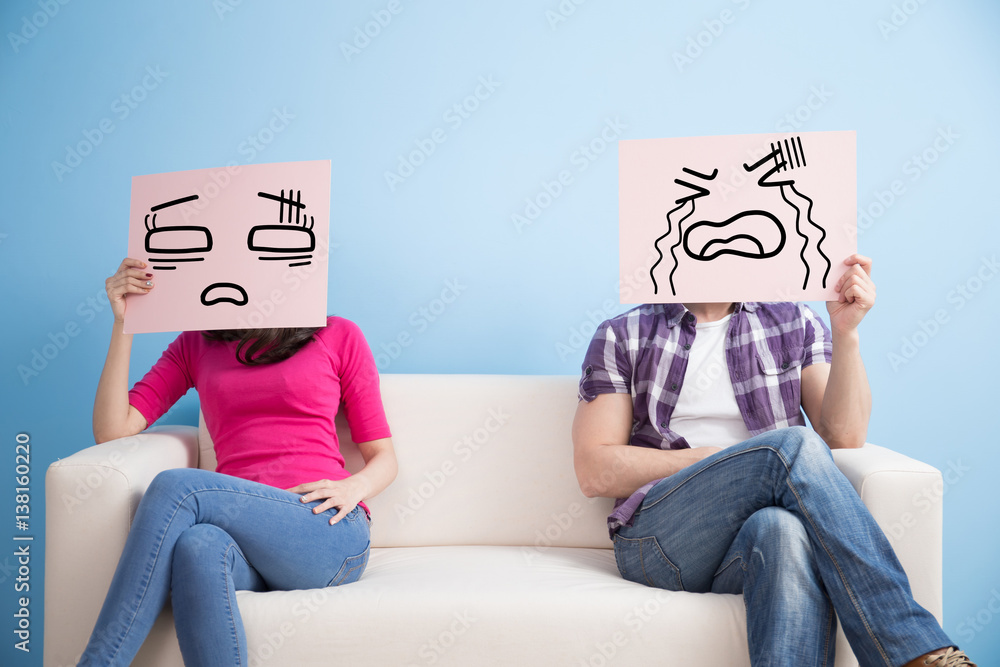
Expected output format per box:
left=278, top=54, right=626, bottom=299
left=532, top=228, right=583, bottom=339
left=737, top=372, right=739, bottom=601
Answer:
left=580, top=302, right=833, bottom=535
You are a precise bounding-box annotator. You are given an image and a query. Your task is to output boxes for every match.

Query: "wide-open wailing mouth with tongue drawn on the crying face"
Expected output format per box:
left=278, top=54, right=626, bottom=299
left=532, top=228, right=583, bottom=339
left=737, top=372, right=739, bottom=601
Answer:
left=684, top=210, right=785, bottom=262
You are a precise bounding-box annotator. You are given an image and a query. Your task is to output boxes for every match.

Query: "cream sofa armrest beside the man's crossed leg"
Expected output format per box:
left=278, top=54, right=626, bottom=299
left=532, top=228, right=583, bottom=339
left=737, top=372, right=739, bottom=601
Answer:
left=833, top=443, right=944, bottom=622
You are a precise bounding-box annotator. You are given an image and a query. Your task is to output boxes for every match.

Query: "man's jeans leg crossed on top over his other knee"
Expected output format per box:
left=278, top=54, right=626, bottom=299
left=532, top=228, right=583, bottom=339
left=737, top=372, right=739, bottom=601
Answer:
left=615, top=427, right=952, bottom=667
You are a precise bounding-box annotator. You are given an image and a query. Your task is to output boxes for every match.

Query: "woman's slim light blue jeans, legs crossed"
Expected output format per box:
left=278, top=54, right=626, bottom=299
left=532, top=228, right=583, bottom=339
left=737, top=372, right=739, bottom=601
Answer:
left=79, top=468, right=369, bottom=667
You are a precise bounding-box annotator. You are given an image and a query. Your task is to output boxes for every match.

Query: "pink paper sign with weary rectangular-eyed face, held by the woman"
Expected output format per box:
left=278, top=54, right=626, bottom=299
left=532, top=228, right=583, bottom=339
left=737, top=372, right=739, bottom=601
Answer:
left=125, top=160, right=330, bottom=333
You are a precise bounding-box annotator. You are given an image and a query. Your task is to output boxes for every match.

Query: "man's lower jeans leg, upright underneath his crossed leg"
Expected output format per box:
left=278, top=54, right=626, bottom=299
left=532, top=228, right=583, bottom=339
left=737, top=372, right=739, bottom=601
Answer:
left=712, top=507, right=837, bottom=667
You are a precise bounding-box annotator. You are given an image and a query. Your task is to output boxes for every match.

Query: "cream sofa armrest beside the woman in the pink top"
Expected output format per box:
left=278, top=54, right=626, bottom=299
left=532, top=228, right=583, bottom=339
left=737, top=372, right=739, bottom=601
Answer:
left=44, top=426, right=198, bottom=665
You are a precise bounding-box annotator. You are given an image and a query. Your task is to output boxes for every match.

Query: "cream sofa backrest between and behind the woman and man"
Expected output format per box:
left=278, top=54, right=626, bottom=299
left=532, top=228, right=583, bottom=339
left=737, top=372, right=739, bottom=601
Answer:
left=199, top=375, right=613, bottom=558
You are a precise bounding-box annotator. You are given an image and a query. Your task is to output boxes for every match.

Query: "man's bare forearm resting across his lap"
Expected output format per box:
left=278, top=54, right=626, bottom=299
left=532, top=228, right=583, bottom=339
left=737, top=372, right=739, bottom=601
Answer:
left=576, top=445, right=718, bottom=498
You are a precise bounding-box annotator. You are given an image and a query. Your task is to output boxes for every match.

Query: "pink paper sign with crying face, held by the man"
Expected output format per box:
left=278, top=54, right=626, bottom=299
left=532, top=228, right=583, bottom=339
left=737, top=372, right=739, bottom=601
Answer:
left=618, top=132, right=857, bottom=303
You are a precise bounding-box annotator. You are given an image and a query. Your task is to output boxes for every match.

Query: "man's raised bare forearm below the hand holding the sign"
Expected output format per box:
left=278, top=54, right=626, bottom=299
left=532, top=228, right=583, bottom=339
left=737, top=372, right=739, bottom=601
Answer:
left=816, top=329, right=872, bottom=449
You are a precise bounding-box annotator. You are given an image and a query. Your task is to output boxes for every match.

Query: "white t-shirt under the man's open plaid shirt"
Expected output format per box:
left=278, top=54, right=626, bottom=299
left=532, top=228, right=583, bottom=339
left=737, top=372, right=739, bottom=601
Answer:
left=670, top=313, right=750, bottom=447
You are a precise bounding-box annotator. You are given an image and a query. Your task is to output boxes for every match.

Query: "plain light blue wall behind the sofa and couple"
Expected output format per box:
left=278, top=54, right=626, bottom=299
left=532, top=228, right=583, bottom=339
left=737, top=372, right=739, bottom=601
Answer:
left=0, top=0, right=1000, bottom=665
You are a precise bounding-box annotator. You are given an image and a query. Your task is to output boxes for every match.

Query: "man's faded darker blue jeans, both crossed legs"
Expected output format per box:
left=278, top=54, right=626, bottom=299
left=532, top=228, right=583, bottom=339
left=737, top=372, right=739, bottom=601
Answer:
left=615, top=426, right=953, bottom=667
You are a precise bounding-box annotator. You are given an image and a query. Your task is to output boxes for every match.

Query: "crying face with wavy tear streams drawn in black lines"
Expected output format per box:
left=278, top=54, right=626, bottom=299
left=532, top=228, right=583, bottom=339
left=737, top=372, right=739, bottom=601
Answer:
left=649, top=137, right=831, bottom=296
